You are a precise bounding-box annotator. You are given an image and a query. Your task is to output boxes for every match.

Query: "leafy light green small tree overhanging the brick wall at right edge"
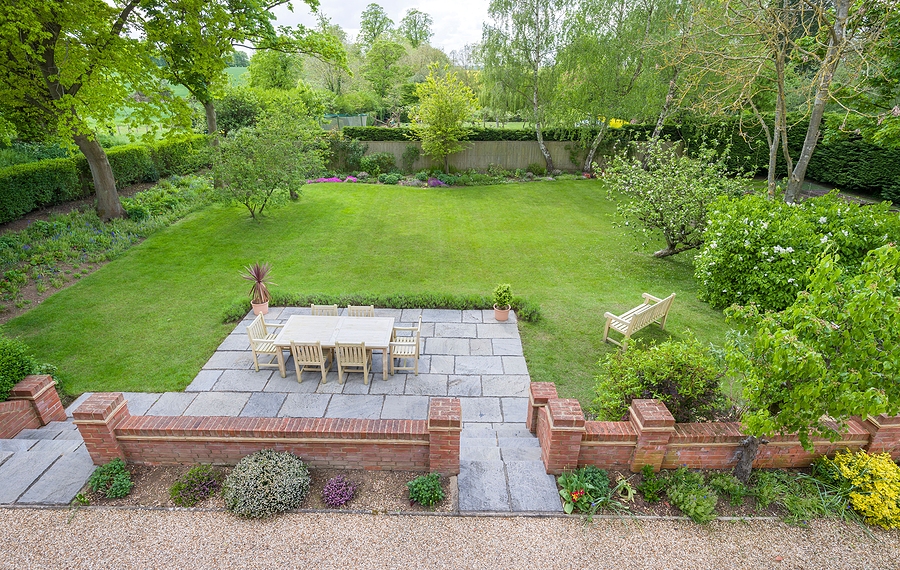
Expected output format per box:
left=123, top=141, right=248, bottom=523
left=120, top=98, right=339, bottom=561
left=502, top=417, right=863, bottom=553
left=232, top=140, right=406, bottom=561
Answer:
left=726, top=245, right=900, bottom=449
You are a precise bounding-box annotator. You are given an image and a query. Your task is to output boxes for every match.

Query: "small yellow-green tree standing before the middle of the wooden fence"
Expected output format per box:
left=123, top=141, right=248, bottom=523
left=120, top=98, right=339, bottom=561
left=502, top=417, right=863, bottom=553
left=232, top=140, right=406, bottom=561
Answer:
left=412, top=65, right=478, bottom=173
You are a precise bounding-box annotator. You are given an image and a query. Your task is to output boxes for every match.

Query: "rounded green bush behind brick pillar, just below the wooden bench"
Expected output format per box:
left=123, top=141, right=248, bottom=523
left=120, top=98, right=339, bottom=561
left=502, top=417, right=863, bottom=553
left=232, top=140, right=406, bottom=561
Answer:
left=591, top=333, right=725, bottom=422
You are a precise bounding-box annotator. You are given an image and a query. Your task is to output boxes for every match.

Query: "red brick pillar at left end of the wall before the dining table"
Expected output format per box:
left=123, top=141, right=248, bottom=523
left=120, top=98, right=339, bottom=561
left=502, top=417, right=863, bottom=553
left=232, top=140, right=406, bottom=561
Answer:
left=72, top=392, right=131, bottom=465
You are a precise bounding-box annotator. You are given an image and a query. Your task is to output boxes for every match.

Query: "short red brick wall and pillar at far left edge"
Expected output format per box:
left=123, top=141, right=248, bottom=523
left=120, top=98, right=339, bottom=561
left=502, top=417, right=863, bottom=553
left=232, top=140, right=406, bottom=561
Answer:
left=0, top=375, right=66, bottom=439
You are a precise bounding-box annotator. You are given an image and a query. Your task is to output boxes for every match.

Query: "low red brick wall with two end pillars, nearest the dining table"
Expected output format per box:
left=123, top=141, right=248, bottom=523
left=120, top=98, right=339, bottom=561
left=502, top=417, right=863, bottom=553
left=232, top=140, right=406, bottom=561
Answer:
left=73, top=393, right=462, bottom=475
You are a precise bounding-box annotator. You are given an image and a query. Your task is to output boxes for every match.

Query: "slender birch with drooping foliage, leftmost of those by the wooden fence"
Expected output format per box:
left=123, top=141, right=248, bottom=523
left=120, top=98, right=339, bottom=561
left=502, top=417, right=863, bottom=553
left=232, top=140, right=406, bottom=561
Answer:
left=482, top=0, right=565, bottom=172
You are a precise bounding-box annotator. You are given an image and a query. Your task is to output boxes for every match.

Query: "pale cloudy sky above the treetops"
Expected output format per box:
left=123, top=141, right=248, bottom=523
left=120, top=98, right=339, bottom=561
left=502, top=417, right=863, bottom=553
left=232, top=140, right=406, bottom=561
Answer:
left=272, top=0, right=489, bottom=54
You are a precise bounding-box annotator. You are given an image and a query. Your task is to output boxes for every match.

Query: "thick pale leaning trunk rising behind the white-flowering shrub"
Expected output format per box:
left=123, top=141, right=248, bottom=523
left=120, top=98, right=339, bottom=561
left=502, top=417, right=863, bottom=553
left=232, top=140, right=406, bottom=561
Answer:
left=784, top=0, right=850, bottom=204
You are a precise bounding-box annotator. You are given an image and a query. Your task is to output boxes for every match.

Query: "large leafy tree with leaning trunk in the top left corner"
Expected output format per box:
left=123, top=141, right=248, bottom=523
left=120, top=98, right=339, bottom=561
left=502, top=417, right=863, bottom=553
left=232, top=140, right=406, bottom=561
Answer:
left=0, top=0, right=164, bottom=219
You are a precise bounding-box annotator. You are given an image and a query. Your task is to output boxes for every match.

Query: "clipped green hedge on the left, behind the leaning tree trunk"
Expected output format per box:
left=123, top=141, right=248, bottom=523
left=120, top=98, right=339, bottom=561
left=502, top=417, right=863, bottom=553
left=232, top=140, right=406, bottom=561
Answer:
left=0, top=135, right=211, bottom=223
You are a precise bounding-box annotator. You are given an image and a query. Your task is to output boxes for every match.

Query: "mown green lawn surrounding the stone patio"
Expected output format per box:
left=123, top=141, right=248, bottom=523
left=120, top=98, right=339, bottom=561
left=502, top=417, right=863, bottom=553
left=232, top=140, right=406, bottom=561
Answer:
left=6, top=180, right=726, bottom=404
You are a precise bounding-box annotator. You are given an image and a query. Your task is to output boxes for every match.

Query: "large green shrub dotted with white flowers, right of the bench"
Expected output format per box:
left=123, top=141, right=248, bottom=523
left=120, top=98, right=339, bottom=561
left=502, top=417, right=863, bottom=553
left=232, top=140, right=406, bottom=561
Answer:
left=694, top=192, right=900, bottom=311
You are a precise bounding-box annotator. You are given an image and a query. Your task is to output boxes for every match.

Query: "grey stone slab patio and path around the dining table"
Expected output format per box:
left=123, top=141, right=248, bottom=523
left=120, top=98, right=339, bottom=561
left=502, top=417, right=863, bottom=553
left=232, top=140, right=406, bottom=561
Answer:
left=0, top=307, right=561, bottom=512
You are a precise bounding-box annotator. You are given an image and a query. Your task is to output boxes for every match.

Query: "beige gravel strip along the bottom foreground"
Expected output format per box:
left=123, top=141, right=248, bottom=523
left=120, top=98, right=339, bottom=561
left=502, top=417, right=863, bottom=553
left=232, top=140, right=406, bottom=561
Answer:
left=0, top=508, right=900, bottom=570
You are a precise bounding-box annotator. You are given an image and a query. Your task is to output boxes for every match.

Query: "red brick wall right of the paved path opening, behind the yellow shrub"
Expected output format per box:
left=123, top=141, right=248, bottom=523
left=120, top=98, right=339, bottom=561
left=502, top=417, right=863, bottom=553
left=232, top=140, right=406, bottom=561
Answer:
left=528, top=382, right=900, bottom=474
